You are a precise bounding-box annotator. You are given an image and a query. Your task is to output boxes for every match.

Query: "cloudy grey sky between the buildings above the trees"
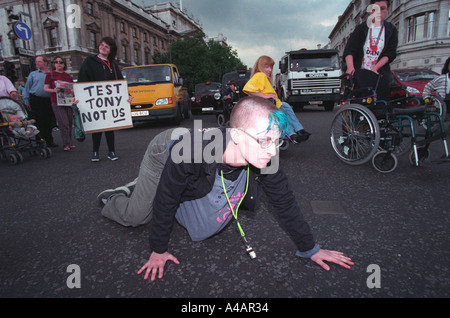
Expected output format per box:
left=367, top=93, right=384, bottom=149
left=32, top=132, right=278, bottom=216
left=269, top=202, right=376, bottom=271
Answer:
left=139, top=0, right=350, bottom=67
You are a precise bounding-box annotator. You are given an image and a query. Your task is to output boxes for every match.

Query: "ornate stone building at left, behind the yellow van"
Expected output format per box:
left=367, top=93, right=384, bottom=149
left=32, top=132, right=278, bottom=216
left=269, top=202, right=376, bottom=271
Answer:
left=0, top=0, right=202, bottom=79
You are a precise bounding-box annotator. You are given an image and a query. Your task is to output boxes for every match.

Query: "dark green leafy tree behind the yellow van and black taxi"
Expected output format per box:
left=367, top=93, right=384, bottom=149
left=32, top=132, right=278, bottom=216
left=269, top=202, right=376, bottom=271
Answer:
left=153, top=33, right=246, bottom=91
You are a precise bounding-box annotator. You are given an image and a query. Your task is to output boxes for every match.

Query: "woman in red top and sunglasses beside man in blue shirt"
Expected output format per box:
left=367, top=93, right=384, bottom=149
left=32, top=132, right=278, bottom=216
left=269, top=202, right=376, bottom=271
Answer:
left=44, top=56, right=75, bottom=151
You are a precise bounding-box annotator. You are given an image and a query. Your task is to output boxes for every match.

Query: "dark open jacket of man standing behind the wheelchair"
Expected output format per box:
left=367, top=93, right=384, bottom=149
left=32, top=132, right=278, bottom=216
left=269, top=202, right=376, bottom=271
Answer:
left=343, top=21, right=398, bottom=76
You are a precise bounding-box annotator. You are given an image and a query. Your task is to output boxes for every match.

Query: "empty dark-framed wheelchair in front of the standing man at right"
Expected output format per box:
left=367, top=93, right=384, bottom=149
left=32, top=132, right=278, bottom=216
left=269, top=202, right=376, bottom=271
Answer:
left=330, top=70, right=449, bottom=173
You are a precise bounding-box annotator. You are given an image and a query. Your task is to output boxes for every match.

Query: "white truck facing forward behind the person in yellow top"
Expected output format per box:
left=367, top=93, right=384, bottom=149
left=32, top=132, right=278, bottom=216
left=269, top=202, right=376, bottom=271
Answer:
left=276, top=49, right=342, bottom=111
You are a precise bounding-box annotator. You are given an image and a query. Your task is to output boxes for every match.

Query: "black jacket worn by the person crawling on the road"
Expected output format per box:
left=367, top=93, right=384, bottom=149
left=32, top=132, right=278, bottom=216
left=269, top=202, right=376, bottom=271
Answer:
left=150, top=128, right=316, bottom=253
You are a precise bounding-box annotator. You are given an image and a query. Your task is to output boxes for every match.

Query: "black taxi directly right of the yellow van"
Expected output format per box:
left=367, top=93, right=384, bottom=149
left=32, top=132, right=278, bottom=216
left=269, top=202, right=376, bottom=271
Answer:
left=191, top=82, right=223, bottom=114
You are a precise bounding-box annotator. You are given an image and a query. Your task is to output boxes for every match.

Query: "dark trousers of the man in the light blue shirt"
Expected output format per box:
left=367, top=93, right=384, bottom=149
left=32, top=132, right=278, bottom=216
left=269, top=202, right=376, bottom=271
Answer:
left=30, top=94, right=55, bottom=145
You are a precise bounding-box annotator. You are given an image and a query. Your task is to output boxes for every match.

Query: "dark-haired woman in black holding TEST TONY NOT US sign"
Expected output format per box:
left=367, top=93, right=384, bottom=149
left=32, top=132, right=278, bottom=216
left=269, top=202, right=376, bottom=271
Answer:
left=78, top=37, right=131, bottom=162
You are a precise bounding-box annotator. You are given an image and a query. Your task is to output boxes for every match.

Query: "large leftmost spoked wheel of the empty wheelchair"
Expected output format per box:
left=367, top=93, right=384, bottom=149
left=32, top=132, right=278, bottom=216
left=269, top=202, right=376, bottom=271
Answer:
left=330, top=104, right=380, bottom=165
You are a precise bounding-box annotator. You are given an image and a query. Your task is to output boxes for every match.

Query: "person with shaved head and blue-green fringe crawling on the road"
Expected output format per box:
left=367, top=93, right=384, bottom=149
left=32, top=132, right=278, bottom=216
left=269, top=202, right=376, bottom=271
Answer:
left=98, top=97, right=353, bottom=281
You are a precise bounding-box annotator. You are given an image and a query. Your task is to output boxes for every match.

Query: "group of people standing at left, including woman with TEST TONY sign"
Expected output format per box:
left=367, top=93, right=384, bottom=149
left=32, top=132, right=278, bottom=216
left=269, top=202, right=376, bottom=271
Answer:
left=0, top=37, right=131, bottom=162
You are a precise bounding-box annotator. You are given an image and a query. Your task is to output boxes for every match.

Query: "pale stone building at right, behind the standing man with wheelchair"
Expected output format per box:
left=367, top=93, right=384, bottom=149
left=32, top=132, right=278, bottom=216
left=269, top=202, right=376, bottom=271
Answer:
left=329, top=0, right=450, bottom=73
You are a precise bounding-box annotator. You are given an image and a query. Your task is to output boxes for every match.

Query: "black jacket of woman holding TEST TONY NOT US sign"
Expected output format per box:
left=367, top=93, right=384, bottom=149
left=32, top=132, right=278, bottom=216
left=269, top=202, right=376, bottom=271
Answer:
left=78, top=55, right=123, bottom=82
